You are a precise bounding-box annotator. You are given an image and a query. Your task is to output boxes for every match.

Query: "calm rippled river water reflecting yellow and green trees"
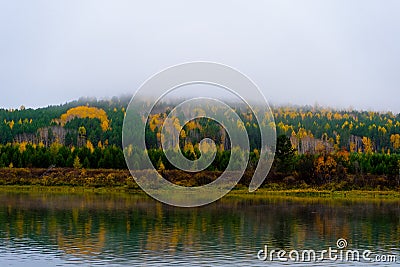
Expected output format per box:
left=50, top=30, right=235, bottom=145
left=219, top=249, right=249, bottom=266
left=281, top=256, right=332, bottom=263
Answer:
left=0, top=193, right=400, bottom=266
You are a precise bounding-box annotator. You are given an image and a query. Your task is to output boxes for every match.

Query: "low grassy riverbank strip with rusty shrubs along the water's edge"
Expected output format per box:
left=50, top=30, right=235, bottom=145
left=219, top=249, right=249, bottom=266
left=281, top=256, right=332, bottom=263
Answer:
left=0, top=168, right=400, bottom=199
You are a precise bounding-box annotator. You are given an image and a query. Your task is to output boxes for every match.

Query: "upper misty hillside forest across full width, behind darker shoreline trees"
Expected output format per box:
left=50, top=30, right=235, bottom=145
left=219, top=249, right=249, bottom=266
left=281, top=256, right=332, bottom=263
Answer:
left=0, top=97, right=400, bottom=154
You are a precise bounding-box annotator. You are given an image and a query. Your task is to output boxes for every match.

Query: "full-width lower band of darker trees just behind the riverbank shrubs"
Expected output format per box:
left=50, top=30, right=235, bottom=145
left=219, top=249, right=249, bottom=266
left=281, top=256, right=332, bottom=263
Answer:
left=0, top=135, right=400, bottom=189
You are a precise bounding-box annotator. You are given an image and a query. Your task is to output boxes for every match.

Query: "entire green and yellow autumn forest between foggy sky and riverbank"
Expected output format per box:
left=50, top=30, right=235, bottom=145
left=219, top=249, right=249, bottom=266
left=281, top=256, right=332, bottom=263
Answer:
left=0, top=97, right=400, bottom=189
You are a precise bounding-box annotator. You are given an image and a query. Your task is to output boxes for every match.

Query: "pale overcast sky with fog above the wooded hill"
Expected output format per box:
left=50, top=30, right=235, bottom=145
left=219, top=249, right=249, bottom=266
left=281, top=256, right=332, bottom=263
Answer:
left=0, top=0, right=400, bottom=113
